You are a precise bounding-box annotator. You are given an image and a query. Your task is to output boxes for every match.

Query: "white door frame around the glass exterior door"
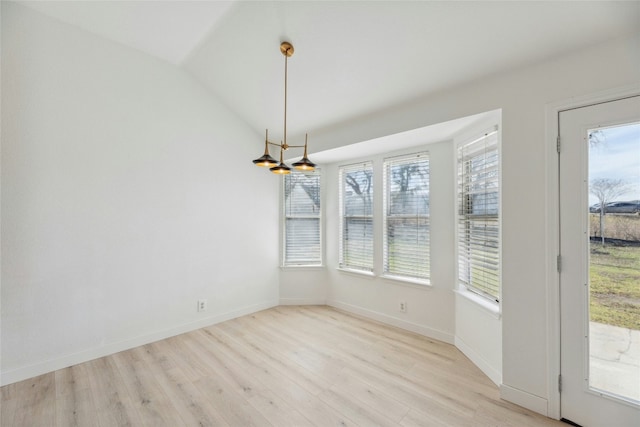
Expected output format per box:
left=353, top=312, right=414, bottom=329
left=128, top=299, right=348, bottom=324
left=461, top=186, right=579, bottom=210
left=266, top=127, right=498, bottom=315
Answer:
left=545, top=84, right=640, bottom=419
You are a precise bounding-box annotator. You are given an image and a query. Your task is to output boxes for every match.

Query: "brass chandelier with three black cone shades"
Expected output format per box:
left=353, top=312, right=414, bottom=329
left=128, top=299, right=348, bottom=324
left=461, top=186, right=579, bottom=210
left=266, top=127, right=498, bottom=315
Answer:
left=253, top=42, right=316, bottom=175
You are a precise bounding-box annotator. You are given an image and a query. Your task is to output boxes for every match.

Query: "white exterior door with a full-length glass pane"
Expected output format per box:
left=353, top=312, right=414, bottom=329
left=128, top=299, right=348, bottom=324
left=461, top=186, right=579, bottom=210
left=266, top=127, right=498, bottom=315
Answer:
left=559, top=96, right=640, bottom=427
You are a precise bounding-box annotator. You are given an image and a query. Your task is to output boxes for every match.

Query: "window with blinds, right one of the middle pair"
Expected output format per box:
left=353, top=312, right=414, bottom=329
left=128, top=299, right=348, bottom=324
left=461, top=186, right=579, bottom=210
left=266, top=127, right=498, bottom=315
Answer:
left=383, top=153, right=430, bottom=281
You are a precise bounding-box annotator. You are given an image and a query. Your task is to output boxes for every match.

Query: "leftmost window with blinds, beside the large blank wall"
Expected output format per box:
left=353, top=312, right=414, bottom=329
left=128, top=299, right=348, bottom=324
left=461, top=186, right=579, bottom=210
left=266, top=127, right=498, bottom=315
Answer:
left=282, top=169, right=322, bottom=266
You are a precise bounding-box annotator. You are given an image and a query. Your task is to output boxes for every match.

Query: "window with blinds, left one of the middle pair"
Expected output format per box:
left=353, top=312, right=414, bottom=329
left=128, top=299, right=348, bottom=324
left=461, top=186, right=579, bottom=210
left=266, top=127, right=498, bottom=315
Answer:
left=339, top=162, right=373, bottom=271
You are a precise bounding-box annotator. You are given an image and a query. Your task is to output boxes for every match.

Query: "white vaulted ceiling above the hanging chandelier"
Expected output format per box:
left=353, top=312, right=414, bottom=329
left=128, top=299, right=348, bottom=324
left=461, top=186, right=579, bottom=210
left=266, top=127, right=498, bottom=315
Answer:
left=15, top=1, right=640, bottom=148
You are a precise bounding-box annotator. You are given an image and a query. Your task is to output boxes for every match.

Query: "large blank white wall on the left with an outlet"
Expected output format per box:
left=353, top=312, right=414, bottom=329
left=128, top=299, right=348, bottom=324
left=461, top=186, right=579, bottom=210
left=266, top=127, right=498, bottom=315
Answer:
left=1, top=2, right=279, bottom=384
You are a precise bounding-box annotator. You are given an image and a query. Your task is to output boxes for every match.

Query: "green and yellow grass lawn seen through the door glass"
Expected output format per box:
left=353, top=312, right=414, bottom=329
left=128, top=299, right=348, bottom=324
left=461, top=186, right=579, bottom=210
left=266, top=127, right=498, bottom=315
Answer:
left=589, top=241, right=640, bottom=330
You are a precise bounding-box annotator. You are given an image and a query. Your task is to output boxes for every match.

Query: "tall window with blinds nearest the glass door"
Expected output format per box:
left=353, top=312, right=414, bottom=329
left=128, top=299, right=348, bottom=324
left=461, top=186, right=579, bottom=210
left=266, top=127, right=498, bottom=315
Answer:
left=457, top=130, right=500, bottom=302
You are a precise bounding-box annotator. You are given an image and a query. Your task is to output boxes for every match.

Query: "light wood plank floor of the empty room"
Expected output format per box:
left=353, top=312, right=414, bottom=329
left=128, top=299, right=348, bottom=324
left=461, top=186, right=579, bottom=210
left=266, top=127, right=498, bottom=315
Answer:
left=1, top=306, right=566, bottom=427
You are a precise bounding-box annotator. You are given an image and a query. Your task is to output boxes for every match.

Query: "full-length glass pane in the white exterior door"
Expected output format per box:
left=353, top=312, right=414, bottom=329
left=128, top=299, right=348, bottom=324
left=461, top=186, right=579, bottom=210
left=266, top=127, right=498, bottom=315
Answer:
left=588, top=123, right=640, bottom=403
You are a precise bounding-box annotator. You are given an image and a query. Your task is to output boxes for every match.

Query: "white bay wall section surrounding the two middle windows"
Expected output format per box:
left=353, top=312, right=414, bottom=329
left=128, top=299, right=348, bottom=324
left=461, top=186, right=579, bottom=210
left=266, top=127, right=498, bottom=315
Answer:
left=325, top=141, right=455, bottom=343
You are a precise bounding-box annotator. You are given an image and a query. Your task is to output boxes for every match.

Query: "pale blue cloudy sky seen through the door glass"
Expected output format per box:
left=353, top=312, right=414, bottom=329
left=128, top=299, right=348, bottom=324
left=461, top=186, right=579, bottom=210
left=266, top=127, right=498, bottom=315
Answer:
left=589, top=123, right=640, bottom=205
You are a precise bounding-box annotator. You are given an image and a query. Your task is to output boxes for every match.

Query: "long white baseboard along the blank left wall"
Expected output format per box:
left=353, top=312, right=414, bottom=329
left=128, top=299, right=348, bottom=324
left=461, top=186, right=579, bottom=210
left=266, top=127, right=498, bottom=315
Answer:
left=0, top=300, right=278, bottom=386
